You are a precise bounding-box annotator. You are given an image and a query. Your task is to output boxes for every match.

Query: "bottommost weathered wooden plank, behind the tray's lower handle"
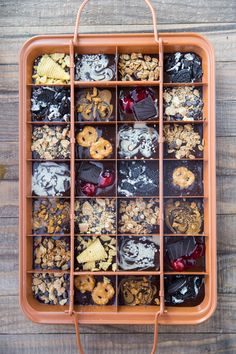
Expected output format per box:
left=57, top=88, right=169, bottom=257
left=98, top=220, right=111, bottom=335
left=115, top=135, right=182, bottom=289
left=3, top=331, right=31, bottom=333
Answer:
left=0, top=333, right=236, bottom=354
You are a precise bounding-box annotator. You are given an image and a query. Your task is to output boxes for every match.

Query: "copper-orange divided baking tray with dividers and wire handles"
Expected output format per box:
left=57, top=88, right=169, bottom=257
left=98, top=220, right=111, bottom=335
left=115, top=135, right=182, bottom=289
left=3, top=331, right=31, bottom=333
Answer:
left=19, top=0, right=217, bottom=352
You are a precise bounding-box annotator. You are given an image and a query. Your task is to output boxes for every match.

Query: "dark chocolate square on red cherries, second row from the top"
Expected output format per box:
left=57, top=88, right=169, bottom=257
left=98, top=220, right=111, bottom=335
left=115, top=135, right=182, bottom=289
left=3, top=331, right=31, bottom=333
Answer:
left=133, top=96, right=157, bottom=120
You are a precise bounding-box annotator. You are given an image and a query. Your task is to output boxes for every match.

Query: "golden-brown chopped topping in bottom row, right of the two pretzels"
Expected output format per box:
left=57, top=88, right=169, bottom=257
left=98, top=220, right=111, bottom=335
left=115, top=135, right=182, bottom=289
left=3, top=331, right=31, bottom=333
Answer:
left=120, top=277, right=160, bottom=306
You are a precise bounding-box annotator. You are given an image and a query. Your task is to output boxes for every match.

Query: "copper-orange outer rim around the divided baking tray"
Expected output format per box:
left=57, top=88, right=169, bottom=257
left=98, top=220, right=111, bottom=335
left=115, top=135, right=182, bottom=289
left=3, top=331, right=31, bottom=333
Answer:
left=19, top=32, right=217, bottom=325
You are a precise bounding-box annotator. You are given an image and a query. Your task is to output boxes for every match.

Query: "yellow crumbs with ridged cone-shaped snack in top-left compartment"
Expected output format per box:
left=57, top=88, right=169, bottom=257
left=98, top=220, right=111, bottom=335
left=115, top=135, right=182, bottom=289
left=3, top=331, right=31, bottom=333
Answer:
left=32, top=53, right=70, bottom=84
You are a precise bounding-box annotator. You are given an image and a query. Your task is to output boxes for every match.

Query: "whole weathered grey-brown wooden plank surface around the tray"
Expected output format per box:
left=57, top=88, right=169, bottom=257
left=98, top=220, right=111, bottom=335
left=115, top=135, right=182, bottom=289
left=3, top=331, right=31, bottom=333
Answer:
left=0, top=0, right=236, bottom=354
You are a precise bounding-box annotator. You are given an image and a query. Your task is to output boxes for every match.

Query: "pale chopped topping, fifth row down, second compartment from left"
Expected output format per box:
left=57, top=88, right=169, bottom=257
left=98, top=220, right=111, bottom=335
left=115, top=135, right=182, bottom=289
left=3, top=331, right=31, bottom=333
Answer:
left=75, top=198, right=116, bottom=234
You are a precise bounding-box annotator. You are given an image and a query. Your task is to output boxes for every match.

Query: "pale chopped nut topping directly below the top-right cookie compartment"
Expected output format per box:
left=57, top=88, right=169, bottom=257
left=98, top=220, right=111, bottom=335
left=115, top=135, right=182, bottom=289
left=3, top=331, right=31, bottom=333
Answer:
left=163, top=86, right=203, bottom=121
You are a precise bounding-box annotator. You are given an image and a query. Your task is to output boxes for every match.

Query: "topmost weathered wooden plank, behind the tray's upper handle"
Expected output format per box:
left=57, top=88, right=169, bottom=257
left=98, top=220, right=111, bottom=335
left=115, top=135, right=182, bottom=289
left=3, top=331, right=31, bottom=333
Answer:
left=0, top=0, right=236, bottom=27
